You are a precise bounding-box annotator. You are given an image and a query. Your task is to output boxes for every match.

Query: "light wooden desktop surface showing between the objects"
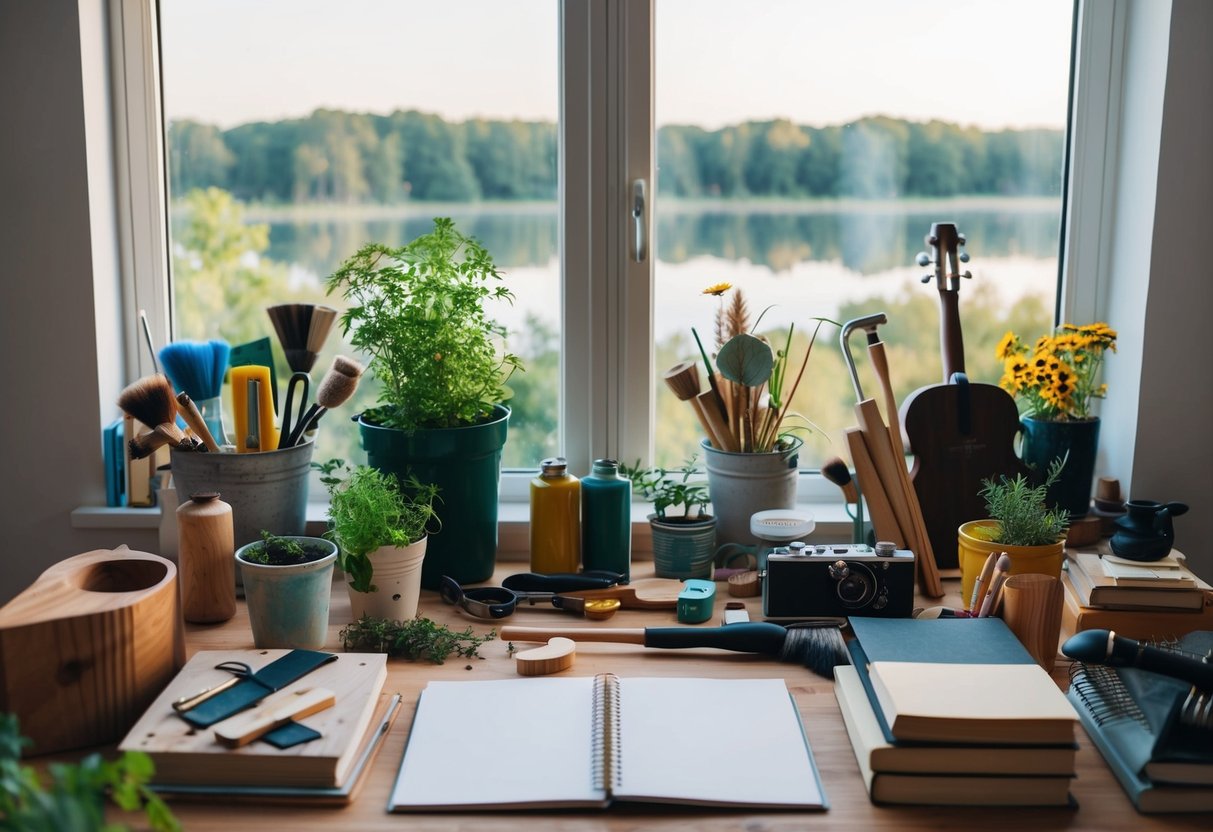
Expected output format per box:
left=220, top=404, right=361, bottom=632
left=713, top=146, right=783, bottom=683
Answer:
left=161, top=563, right=1209, bottom=832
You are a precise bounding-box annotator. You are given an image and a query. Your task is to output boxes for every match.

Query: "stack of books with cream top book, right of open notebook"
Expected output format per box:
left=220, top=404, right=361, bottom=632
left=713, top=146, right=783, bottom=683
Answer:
left=835, top=619, right=1077, bottom=807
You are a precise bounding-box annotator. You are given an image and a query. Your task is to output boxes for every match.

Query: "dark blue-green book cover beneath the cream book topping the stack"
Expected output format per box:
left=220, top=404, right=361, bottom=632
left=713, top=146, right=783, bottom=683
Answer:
left=847, top=617, right=1067, bottom=747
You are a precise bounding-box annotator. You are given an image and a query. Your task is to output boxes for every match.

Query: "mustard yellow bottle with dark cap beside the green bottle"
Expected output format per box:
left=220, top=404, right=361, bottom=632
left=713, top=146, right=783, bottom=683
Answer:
left=530, top=456, right=581, bottom=575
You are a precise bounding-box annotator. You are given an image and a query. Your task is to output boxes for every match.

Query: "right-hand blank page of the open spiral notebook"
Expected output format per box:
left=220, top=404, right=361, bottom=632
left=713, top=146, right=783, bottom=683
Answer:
left=614, top=678, right=825, bottom=807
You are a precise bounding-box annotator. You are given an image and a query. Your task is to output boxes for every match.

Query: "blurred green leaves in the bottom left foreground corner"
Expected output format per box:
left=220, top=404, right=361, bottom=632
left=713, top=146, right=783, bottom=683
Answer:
left=0, top=713, right=181, bottom=832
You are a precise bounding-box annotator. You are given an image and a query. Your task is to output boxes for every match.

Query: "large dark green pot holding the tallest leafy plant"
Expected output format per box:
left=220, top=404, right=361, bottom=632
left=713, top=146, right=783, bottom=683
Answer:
left=358, top=405, right=509, bottom=589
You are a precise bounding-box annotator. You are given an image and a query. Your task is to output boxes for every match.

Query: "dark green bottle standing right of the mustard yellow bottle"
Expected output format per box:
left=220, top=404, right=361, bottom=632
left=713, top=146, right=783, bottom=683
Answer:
left=581, top=460, right=632, bottom=580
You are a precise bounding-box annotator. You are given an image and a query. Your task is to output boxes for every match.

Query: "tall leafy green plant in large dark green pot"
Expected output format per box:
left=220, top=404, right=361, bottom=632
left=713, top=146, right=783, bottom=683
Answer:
left=325, top=217, right=522, bottom=588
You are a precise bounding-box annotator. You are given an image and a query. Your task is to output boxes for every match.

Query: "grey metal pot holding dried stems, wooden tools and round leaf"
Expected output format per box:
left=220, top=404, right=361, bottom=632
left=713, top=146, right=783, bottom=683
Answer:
left=667, top=283, right=828, bottom=545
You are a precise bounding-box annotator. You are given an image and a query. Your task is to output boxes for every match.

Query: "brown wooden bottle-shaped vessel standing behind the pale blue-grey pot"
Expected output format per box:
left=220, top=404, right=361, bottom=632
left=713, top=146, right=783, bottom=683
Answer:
left=177, top=491, right=235, bottom=623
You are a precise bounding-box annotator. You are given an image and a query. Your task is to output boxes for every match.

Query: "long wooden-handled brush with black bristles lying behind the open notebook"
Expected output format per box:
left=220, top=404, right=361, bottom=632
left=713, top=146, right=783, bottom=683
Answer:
left=501, top=621, right=850, bottom=679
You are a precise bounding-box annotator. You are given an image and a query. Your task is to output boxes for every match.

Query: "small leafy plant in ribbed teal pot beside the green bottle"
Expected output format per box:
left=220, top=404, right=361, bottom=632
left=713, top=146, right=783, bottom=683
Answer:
left=620, top=457, right=716, bottom=579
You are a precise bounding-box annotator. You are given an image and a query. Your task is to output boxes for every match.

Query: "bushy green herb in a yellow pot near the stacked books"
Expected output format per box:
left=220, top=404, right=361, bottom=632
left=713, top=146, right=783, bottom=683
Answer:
left=957, top=458, right=1070, bottom=600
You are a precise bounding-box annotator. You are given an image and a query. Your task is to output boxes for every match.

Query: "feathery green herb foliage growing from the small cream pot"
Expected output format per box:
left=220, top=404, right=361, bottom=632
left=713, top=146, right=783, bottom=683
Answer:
left=313, top=460, right=438, bottom=592
